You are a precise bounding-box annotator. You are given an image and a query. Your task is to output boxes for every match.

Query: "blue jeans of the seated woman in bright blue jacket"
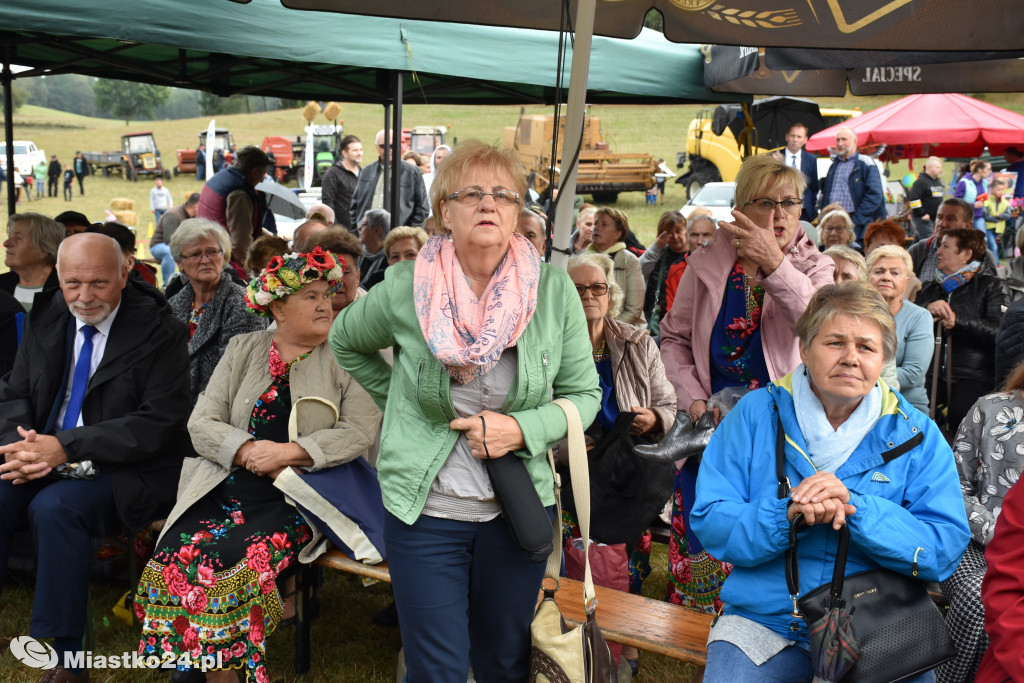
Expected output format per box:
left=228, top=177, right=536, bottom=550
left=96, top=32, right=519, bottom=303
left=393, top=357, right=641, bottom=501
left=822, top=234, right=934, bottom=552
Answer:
left=703, top=640, right=935, bottom=683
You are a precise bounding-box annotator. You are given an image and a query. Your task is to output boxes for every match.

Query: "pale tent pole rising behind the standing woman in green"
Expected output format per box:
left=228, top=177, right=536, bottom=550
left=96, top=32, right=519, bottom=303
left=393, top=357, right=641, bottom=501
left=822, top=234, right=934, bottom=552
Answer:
left=551, top=0, right=597, bottom=268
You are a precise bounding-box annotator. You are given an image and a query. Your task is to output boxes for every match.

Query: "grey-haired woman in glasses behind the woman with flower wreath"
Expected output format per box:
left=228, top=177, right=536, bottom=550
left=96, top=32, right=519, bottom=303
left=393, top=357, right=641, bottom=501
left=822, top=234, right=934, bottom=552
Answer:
left=168, top=218, right=266, bottom=404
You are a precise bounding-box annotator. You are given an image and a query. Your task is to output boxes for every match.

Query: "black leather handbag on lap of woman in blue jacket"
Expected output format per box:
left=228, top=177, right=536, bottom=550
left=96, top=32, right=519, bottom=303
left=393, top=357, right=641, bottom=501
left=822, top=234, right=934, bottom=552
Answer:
left=775, top=411, right=956, bottom=683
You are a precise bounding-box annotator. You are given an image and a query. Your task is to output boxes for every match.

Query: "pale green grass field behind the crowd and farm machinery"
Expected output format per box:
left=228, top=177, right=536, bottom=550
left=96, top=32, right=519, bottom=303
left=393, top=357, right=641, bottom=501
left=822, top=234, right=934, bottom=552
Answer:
left=8, top=94, right=1024, bottom=248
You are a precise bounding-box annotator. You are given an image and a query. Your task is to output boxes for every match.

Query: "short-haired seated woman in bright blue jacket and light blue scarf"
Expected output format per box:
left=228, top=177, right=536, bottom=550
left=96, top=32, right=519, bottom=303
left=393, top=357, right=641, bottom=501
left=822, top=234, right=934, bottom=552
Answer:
left=690, top=282, right=970, bottom=683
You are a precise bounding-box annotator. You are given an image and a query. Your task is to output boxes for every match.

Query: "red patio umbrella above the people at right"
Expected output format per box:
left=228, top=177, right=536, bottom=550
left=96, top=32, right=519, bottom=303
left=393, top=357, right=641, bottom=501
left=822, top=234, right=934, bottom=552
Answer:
left=806, top=94, right=1024, bottom=159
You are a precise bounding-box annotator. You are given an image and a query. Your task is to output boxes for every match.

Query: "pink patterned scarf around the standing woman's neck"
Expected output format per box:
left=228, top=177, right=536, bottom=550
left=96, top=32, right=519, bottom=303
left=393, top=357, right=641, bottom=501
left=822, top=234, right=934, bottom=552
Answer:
left=413, top=232, right=541, bottom=384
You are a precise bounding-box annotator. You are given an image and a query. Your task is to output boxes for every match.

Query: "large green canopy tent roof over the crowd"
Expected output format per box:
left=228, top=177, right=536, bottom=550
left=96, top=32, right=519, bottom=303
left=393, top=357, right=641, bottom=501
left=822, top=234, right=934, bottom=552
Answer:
left=0, top=0, right=745, bottom=216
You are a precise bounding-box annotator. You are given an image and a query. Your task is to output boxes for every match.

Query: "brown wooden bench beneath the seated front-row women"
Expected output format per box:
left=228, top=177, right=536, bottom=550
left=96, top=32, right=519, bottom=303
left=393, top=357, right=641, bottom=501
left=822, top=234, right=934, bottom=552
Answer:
left=295, top=549, right=713, bottom=676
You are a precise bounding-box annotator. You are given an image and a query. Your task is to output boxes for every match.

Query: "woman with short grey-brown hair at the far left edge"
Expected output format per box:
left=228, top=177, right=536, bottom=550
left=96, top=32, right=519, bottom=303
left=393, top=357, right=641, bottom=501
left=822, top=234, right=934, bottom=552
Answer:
left=0, top=213, right=65, bottom=312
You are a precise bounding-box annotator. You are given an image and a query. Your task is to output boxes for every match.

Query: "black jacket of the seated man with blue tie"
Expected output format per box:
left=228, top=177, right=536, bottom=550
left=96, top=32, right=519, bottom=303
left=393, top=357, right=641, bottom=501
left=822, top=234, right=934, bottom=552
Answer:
left=0, top=285, right=195, bottom=530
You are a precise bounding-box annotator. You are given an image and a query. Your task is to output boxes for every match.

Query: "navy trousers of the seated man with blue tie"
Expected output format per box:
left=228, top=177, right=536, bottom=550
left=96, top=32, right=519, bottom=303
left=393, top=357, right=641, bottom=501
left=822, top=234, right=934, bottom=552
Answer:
left=0, top=473, right=121, bottom=638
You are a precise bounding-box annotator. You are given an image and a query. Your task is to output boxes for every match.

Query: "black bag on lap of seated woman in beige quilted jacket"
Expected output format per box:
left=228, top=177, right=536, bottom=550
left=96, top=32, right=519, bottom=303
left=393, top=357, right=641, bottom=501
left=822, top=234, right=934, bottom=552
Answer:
left=559, top=413, right=676, bottom=548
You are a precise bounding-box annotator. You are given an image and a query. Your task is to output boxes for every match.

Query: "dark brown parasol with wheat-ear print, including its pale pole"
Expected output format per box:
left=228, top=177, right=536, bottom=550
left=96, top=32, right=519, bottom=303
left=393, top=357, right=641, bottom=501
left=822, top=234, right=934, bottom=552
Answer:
left=276, top=0, right=1024, bottom=265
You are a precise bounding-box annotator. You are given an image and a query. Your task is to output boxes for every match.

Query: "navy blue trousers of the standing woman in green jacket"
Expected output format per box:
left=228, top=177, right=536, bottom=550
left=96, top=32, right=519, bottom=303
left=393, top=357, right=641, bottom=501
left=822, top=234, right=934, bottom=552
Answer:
left=384, top=510, right=550, bottom=683
